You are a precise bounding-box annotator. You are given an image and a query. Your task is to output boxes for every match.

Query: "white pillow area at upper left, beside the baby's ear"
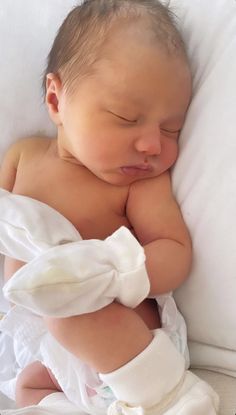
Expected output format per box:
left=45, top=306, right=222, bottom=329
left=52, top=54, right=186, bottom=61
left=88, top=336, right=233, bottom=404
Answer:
left=0, top=0, right=78, bottom=162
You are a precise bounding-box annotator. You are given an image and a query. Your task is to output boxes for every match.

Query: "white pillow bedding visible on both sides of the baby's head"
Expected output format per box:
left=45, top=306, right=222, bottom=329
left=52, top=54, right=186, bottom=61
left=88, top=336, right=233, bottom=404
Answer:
left=0, top=0, right=236, bottom=374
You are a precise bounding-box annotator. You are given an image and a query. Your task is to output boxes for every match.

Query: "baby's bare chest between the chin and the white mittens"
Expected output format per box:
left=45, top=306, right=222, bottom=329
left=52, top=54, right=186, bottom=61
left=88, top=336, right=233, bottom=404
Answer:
left=13, top=159, right=130, bottom=239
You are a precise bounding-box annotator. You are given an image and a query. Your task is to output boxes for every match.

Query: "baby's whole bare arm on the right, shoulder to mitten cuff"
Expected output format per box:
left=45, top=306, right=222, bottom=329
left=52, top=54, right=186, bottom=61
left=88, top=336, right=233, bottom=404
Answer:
left=127, top=173, right=191, bottom=296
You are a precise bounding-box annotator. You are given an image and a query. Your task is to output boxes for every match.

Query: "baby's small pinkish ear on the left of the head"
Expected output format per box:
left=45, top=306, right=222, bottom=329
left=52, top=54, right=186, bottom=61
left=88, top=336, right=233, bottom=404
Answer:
left=45, top=73, right=62, bottom=126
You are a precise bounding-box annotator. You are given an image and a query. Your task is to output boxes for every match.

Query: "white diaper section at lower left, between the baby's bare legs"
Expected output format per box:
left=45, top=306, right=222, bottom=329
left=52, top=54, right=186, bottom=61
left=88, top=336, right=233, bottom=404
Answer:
left=0, top=306, right=101, bottom=415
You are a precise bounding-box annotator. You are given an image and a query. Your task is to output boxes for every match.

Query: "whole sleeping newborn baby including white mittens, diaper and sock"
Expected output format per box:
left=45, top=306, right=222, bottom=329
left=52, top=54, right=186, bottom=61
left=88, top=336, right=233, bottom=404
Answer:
left=0, top=0, right=217, bottom=415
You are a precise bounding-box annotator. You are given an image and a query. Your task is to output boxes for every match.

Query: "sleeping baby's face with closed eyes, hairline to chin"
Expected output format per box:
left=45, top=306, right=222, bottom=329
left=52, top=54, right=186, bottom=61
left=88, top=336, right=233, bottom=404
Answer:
left=55, top=29, right=191, bottom=185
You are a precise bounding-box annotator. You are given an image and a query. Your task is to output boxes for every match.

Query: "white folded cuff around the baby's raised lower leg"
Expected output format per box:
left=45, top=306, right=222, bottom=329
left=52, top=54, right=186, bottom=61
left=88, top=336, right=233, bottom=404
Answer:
left=100, top=329, right=185, bottom=408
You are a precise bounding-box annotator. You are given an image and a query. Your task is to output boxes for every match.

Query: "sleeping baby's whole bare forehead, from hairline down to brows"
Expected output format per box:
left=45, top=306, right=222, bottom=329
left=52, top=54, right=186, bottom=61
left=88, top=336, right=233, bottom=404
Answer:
left=65, top=24, right=191, bottom=113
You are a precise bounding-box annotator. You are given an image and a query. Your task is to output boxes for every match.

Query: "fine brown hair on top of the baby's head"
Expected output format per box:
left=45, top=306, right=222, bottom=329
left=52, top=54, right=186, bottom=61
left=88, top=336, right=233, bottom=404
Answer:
left=43, top=0, right=185, bottom=96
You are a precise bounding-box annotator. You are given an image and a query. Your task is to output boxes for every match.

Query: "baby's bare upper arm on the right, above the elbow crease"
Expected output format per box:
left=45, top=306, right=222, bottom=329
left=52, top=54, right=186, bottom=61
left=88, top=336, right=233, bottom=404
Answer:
left=127, top=172, right=188, bottom=244
